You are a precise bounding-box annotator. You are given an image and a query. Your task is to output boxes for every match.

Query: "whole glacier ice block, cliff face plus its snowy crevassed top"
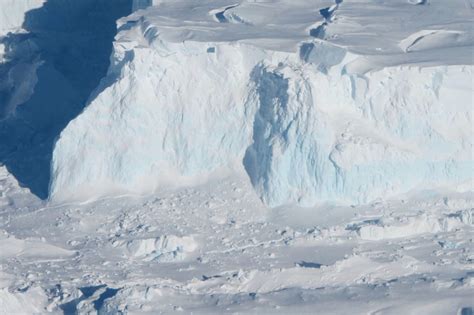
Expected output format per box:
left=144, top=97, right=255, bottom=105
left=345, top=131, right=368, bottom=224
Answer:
left=50, top=1, right=473, bottom=206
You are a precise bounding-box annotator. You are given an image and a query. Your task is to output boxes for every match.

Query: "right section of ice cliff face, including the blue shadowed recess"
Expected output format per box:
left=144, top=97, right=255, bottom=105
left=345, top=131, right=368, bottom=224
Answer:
left=244, top=59, right=473, bottom=206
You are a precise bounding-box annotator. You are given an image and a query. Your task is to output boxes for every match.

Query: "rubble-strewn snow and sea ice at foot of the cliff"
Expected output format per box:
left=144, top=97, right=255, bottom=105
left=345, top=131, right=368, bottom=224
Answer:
left=0, top=167, right=474, bottom=315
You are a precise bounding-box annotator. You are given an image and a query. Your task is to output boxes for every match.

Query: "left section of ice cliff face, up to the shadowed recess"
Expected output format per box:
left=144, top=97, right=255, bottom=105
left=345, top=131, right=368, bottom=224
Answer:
left=51, top=45, right=264, bottom=199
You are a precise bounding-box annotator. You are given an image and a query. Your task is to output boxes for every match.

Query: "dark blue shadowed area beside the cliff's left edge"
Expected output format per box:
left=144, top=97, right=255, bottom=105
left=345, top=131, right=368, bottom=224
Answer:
left=0, top=0, right=132, bottom=199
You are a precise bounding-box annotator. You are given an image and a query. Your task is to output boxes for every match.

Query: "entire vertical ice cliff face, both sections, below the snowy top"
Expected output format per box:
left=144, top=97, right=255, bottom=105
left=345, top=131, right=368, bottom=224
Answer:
left=51, top=39, right=472, bottom=206
